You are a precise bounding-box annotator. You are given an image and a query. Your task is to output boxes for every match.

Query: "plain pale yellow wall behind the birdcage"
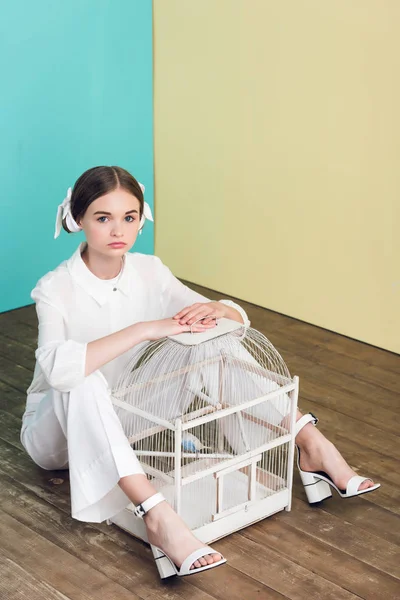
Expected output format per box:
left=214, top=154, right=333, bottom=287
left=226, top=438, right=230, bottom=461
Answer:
left=154, top=0, right=400, bottom=352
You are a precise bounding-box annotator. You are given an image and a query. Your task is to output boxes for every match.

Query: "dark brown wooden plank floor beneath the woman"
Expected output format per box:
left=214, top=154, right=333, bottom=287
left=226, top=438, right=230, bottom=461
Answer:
left=0, top=286, right=400, bottom=600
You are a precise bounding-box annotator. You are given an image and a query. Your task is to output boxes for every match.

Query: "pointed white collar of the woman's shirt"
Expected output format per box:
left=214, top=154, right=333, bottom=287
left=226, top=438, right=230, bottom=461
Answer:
left=67, top=242, right=133, bottom=306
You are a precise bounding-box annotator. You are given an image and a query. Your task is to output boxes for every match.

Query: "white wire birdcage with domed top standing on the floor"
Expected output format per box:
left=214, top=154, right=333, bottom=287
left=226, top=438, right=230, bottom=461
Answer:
left=111, top=319, right=298, bottom=543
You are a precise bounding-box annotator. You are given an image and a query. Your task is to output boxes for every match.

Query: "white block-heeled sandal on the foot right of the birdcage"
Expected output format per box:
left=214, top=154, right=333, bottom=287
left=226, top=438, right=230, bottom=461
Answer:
left=296, top=413, right=381, bottom=504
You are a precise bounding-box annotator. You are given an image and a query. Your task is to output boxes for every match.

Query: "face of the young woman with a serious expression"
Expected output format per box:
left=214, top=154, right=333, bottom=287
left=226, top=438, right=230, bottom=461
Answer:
left=79, top=188, right=140, bottom=257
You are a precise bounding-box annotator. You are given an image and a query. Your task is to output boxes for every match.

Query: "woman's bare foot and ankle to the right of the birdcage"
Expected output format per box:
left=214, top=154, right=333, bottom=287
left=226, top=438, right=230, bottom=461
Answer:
left=296, top=415, right=374, bottom=491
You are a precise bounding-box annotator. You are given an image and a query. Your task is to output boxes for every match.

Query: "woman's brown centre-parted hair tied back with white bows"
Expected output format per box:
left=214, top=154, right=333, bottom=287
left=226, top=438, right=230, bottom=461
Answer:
left=62, top=167, right=144, bottom=233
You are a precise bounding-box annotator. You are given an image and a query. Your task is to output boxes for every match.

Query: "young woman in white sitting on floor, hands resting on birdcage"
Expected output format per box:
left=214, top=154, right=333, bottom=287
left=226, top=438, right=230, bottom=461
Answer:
left=21, top=167, right=378, bottom=575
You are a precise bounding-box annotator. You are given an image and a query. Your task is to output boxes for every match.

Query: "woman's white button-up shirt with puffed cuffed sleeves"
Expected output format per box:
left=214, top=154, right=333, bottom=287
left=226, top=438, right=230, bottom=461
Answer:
left=27, top=243, right=249, bottom=410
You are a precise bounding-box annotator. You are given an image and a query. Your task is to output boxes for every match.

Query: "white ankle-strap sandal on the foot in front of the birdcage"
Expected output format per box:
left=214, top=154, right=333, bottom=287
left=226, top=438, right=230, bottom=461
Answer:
left=133, top=493, right=226, bottom=579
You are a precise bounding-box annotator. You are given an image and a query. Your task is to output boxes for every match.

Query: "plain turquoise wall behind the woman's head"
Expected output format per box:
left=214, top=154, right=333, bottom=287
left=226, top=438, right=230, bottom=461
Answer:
left=0, top=0, right=154, bottom=312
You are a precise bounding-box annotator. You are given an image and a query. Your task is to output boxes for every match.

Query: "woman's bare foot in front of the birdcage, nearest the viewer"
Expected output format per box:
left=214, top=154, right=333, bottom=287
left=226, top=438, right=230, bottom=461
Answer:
left=144, top=502, right=222, bottom=569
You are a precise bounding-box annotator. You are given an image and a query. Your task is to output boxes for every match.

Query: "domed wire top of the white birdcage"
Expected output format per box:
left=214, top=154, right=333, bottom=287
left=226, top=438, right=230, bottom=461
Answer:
left=113, top=319, right=292, bottom=437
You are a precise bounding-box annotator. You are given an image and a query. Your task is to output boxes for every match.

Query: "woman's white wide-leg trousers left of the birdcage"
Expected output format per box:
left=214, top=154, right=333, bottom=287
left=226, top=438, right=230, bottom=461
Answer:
left=21, top=372, right=144, bottom=523
